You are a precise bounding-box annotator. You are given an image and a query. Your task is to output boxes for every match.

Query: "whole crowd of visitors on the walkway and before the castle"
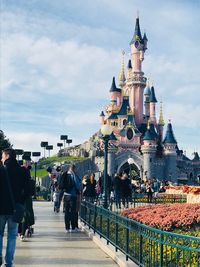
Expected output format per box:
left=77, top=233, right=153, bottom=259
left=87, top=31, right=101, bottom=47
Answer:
left=0, top=148, right=170, bottom=267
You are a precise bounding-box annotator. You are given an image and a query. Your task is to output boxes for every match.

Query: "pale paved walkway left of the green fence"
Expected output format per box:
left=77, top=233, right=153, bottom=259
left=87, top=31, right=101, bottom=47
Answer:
left=5, top=202, right=118, bottom=267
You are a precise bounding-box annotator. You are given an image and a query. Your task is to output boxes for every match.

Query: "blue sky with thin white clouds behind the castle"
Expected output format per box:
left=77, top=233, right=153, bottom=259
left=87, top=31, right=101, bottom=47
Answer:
left=0, top=0, right=200, bottom=158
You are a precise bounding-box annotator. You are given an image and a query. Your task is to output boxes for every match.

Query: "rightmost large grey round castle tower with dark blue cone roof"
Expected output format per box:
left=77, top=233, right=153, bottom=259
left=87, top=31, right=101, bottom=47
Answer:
left=163, top=121, right=177, bottom=182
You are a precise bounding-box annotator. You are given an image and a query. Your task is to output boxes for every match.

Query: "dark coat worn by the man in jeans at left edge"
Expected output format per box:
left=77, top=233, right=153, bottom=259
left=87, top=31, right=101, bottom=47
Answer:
left=0, top=159, right=29, bottom=215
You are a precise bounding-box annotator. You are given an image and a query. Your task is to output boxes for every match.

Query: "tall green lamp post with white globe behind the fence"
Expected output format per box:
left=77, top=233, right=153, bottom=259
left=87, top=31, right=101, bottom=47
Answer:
left=101, top=124, right=113, bottom=209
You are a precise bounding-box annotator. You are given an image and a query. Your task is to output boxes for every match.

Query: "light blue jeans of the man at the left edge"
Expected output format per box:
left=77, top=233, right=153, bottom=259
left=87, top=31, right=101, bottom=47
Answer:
left=0, top=215, right=18, bottom=267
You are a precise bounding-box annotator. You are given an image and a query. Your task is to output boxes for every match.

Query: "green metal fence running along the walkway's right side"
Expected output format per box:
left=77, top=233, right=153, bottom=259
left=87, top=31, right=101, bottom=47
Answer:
left=80, top=201, right=200, bottom=267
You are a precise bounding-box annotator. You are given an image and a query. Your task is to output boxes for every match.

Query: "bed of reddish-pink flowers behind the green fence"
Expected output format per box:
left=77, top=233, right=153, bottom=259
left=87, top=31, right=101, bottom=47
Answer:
left=122, top=204, right=200, bottom=231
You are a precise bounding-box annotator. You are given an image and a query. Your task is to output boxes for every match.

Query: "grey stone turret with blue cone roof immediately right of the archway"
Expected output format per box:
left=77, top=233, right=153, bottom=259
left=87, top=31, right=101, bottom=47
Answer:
left=141, top=122, right=157, bottom=179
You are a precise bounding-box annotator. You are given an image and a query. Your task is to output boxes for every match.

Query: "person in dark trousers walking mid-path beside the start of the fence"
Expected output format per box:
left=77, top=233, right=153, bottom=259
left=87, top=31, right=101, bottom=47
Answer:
left=60, top=164, right=81, bottom=233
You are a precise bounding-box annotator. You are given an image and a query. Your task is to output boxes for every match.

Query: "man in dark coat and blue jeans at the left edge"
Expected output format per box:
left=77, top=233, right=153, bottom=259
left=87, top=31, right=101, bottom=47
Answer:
left=0, top=148, right=29, bottom=267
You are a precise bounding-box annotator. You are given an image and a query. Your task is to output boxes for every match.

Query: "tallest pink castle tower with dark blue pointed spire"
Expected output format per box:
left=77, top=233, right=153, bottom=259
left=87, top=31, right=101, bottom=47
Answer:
left=129, top=17, right=148, bottom=125
